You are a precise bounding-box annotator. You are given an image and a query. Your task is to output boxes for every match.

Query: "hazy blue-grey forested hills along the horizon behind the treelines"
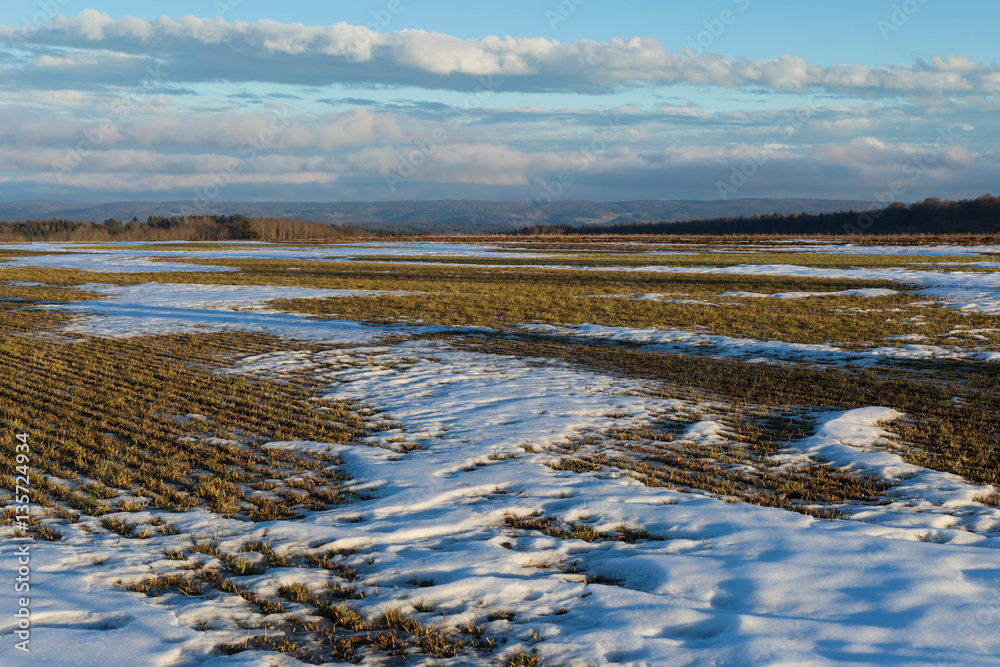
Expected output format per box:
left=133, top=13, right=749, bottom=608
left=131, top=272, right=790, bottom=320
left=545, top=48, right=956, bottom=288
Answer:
left=0, top=199, right=875, bottom=233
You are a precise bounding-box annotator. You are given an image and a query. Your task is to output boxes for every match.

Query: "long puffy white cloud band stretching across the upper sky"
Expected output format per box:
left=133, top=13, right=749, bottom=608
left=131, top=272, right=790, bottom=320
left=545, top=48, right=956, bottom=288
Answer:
left=0, top=10, right=1000, bottom=96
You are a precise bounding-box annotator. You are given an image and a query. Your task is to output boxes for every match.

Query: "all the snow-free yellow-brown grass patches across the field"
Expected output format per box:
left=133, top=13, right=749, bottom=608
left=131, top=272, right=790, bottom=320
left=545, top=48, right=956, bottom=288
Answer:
left=0, top=241, right=1000, bottom=665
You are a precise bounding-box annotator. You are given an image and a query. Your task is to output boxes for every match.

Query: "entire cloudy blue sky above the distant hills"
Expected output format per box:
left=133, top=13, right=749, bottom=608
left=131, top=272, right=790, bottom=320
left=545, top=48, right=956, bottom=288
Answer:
left=0, top=0, right=1000, bottom=203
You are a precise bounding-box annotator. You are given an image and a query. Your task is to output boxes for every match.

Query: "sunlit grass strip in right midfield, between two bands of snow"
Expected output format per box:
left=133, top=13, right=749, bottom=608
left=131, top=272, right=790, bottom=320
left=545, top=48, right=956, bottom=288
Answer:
left=273, top=290, right=1000, bottom=347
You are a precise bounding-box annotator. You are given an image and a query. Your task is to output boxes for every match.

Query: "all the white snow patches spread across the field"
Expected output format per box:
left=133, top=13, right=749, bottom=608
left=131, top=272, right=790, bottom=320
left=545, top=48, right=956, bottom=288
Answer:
left=0, top=243, right=1000, bottom=667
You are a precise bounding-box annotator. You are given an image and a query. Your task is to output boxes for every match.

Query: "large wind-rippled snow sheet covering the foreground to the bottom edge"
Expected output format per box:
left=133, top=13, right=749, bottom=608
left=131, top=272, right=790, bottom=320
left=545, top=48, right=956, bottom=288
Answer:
left=0, top=342, right=1000, bottom=666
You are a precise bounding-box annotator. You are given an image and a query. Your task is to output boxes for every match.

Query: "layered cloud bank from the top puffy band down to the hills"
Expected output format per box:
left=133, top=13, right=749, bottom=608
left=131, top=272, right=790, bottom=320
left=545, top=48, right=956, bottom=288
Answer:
left=0, top=10, right=1000, bottom=200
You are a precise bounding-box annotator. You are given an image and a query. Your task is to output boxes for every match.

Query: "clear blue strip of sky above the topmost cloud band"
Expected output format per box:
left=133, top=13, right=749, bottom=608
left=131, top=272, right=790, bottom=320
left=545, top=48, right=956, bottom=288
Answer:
left=0, top=0, right=1000, bottom=65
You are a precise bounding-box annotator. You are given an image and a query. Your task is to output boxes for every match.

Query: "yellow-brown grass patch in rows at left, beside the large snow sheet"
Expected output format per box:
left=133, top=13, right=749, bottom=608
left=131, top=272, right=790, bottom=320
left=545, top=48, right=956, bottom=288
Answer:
left=0, top=326, right=365, bottom=534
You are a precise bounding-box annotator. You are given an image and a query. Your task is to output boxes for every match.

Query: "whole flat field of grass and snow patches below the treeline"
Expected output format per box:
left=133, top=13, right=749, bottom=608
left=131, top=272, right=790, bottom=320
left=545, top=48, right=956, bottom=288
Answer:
left=0, top=238, right=1000, bottom=666
